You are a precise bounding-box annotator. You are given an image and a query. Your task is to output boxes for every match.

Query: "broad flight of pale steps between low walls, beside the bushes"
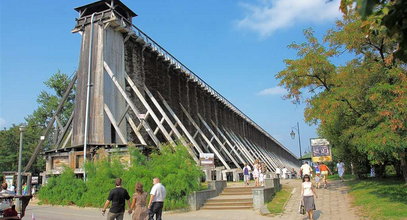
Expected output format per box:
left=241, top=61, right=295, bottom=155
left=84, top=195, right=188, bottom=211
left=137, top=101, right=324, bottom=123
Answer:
left=201, top=187, right=260, bottom=210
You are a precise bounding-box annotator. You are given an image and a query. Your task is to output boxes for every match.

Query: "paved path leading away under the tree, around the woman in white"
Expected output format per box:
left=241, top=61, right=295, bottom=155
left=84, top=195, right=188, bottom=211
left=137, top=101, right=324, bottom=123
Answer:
left=271, top=180, right=361, bottom=220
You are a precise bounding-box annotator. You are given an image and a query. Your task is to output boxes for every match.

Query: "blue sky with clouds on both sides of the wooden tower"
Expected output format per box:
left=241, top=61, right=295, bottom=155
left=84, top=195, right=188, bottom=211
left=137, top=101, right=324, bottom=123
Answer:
left=0, top=0, right=340, bottom=158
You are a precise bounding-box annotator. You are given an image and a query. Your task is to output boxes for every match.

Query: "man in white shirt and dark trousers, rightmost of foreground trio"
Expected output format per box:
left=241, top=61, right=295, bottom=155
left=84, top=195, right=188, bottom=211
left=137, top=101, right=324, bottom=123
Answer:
left=148, top=177, right=167, bottom=220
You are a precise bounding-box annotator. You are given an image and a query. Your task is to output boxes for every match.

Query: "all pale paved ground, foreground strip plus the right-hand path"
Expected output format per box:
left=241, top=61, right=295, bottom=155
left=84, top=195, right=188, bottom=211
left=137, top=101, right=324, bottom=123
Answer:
left=24, top=180, right=361, bottom=220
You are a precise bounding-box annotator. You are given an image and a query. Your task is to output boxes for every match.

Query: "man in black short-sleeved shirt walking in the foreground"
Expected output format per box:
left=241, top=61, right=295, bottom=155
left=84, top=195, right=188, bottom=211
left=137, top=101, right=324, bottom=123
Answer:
left=102, top=178, right=130, bottom=220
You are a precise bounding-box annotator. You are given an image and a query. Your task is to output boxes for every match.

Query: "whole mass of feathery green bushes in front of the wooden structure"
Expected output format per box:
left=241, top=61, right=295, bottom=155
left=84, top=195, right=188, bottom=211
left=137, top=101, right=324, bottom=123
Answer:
left=40, top=145, right=202, bottom=210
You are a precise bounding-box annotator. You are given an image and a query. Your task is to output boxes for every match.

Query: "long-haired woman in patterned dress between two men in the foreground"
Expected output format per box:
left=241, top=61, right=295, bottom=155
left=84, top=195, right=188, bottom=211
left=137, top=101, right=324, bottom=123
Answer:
left=129, top=183, right=148, bottom=220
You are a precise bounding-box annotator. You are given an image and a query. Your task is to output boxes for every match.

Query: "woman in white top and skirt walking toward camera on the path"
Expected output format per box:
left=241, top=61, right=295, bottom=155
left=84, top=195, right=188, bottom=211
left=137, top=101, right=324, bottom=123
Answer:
left=301, top=174, right=318, bottom=219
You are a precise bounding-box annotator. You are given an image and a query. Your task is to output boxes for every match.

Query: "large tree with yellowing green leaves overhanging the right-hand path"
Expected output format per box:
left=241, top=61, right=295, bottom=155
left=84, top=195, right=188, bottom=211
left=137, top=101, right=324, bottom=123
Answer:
left=276, top=11, right=407, bottom=182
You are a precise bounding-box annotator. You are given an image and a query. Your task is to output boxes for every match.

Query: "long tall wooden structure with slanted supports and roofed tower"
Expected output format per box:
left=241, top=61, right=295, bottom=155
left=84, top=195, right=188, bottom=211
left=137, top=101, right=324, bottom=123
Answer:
left=27, top=0, right=298, bottom=181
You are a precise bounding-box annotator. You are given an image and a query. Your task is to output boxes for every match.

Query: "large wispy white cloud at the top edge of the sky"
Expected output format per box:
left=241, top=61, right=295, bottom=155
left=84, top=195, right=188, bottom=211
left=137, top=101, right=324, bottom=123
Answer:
left=237, top=0, right=341, bottom=37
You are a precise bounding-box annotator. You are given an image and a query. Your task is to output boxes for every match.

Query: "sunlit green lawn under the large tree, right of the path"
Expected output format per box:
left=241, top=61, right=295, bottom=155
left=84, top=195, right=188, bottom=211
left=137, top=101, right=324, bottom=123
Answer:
left=346, top=179, right=407, bottom=219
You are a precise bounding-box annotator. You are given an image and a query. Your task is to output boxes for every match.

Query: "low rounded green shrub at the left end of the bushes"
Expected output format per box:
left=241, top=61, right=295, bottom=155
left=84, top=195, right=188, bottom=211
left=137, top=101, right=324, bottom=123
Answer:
left=39, top=168, right=86, bottom=205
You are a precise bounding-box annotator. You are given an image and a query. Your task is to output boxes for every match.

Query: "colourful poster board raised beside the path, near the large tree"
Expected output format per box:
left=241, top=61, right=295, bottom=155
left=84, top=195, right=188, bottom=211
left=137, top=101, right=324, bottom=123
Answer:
left=310, top=138, right=332, bottom=163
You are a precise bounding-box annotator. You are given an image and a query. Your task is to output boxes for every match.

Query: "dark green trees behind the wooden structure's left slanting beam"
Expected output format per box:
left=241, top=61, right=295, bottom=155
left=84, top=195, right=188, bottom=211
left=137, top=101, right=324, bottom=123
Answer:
left=0, top=71, right=75, bottom=173
